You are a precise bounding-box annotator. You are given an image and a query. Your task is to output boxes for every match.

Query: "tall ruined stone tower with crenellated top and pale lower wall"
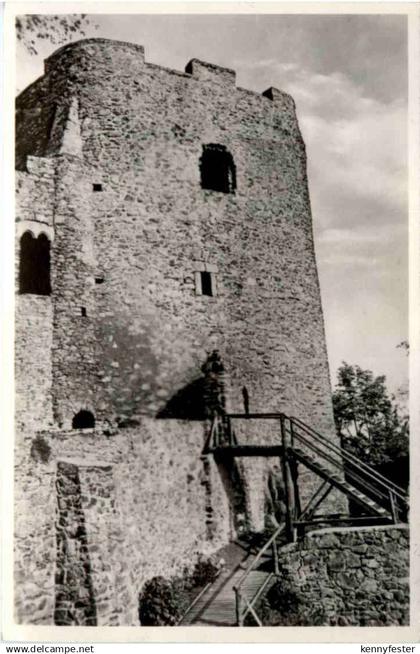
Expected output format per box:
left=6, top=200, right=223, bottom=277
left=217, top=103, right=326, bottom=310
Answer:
left=16, top=39, right=342, bottom=625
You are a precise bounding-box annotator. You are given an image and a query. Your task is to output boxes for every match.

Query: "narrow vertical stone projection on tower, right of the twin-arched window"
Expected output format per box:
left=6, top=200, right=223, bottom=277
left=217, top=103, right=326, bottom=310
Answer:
left=51, top=155, right=102, bottom=429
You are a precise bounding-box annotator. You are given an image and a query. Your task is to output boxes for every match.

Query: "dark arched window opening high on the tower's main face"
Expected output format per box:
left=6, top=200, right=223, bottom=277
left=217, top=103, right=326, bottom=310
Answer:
left=200, top=143, right=236, bottom=193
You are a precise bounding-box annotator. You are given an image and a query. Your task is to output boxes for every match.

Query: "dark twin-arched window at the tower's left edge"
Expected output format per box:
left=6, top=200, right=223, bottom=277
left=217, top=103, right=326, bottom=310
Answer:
left=19, top=232, right=51, bottom=295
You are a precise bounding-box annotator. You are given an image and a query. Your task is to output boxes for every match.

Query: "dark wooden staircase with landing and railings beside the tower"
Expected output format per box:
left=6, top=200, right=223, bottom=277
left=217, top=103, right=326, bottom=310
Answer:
left=204, top=413, right=409, bottom=626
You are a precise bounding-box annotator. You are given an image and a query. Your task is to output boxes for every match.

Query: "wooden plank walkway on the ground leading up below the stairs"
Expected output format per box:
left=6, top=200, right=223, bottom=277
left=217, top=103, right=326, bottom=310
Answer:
left=181, top=556, right=271, bottom=627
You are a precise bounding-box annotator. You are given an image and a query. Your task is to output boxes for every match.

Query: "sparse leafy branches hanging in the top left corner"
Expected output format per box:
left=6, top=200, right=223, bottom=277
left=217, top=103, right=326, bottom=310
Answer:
left=16, top=14, right=91, bottom=55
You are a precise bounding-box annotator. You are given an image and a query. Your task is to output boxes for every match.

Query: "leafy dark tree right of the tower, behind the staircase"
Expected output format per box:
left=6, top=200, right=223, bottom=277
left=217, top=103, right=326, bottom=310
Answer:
left=333, top=363, right=409, bottom=466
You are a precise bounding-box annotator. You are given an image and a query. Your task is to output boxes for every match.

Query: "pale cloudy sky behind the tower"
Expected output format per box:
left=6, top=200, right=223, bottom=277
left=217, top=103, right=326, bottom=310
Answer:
left=17, top=14, right=408, bottom=392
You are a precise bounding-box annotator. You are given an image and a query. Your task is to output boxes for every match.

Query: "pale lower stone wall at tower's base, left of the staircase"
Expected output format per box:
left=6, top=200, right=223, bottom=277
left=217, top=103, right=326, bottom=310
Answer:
left=16, top=418, right=237, bottom=626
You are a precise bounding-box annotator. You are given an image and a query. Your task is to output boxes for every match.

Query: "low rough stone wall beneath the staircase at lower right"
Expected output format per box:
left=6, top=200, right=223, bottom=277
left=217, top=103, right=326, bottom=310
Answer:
left=279, top=525, right=410, bottom=626
